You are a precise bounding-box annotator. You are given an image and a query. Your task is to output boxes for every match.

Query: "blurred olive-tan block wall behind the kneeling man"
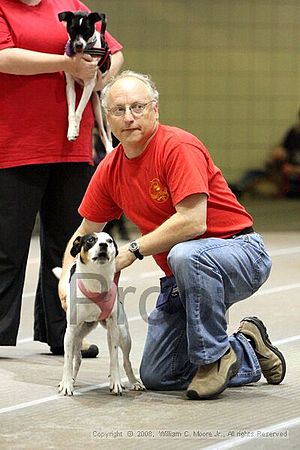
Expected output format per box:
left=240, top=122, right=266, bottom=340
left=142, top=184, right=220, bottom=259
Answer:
left=85, top=0, right=300, bottom=181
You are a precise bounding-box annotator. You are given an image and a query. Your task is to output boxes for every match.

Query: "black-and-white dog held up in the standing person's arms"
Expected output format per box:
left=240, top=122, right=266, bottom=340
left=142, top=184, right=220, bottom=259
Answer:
left=58, top=11, right=112, bottom=149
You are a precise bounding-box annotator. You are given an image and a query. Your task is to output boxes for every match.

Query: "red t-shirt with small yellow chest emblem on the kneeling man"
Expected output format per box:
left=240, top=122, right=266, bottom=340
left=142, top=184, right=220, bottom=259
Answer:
left=79, top=125, right=253, bottom=275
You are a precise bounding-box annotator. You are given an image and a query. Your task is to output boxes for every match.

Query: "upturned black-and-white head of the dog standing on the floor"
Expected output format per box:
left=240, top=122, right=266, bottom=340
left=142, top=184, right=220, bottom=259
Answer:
left=71, top=232, right=118, bottom=264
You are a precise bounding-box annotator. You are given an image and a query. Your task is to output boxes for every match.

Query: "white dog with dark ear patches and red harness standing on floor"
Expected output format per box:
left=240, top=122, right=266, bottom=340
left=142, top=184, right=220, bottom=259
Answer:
left=53, top=232, right=145, bottom=395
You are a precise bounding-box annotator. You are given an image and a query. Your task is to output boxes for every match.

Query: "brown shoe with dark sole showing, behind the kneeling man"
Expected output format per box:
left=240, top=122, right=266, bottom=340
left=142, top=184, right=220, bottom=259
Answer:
left=238, top=316, right=286, bottom=384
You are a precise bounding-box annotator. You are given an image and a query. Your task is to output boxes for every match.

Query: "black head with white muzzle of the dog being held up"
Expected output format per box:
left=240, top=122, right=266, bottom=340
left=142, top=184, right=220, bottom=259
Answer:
left=58, top=11, right=105, bottom=53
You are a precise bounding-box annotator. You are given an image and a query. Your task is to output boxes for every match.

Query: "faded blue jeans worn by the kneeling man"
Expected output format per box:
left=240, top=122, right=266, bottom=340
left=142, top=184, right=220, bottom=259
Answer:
left=140, top=233, right=271, bottom=390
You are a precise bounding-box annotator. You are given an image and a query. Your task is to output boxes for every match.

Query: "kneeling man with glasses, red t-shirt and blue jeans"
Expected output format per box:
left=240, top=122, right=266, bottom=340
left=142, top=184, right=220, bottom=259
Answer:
left=59, top=71, right=286, bottom=399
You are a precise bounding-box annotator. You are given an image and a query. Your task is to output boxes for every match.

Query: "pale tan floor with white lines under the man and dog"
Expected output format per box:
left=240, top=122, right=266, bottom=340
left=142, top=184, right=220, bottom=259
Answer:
left=0, top=233, right=300, bottom=450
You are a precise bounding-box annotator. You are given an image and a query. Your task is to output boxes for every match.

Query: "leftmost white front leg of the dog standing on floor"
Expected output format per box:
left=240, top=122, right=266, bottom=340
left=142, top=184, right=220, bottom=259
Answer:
left=58, top=325, right=75, bottom=395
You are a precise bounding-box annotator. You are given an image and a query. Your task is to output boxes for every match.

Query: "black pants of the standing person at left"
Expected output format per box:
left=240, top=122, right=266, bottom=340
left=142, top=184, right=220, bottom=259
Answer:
left=0, top=163, right=93, bottom=346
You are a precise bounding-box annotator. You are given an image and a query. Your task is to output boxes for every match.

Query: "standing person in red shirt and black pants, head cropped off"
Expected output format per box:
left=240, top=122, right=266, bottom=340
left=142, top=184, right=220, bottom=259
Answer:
left=0, top=0, right=123, bottom=356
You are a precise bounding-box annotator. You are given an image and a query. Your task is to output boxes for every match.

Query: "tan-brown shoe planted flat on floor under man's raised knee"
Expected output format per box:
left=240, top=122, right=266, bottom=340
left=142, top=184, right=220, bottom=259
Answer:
left=187, top=348, right=239, bottom=400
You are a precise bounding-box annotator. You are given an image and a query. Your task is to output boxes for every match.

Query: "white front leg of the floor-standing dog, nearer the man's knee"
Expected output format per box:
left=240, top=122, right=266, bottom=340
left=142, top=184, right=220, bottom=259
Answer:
left=106, top=314, right=125, bottom=395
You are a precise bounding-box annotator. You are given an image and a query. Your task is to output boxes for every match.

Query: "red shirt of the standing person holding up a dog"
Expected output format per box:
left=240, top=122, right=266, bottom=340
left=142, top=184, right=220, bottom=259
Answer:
left=0, top=0, right=122, bottom=168
